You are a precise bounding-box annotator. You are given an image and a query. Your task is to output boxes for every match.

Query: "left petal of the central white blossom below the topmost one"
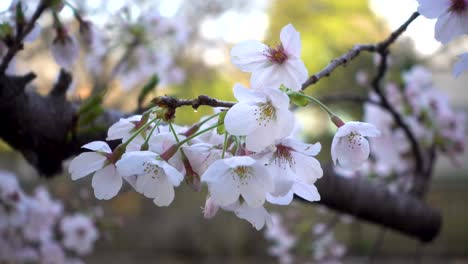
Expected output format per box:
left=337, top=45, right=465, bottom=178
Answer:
left=224, top=103, right=258, bottom=136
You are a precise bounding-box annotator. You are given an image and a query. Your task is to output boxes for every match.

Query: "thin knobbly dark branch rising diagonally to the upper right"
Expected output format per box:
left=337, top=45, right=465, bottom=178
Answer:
left=302, top=12, right=419, bottom=91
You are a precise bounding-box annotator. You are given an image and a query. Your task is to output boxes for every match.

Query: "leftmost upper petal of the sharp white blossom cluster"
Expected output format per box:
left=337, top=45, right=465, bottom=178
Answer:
left=68, top=152, right=107, bottom=180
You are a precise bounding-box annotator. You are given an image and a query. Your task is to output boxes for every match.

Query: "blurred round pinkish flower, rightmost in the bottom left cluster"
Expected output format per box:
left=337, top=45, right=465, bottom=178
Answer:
left=60, top=213, right=99, bottom=256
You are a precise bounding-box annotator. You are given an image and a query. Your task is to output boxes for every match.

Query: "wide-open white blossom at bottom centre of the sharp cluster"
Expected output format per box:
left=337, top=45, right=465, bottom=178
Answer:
left=201, top=156, right=274, bottom=208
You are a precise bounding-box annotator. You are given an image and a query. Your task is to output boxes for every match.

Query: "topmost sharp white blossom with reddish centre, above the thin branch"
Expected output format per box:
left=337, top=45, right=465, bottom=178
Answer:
left=231, top=24, right=308, bottom=91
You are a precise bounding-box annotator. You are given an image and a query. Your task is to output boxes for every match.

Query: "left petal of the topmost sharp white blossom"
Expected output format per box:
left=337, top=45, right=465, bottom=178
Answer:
left=231, top=40, right=268, bottom=72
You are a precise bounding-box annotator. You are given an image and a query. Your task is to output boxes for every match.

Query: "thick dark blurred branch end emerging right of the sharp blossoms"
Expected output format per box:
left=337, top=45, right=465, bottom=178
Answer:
left=310, top=170, right=442, bottom=242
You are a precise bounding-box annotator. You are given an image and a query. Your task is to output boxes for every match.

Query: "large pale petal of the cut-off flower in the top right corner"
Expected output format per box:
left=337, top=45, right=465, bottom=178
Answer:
left=435, top=12, right=467, bottom=44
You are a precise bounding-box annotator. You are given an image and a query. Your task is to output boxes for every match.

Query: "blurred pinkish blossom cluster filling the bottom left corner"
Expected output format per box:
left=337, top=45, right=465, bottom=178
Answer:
left=0, top=171, right=99, bottom=263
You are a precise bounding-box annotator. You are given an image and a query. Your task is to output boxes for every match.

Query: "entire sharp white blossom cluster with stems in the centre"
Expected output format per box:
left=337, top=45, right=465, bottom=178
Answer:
left=69, top=24, right=379, bottom=229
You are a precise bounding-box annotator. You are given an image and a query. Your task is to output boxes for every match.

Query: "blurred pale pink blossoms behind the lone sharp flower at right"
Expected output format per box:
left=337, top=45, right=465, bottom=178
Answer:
left=339, top=65, right=466, bottom=191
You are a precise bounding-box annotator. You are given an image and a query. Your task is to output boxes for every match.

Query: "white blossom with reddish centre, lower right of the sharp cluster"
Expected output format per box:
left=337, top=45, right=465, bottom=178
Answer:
left=264, top=138, right=323, bottom=197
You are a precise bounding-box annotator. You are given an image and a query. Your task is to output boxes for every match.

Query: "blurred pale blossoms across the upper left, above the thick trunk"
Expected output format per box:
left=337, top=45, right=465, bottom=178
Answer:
left=0, top=1, right=186, bottom=91
